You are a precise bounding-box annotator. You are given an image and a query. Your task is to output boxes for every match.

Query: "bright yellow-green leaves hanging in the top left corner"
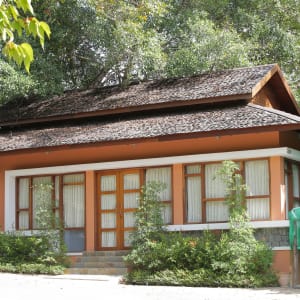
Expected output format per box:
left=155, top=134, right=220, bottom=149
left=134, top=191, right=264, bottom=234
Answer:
left=0, top=0, right=51, bottom=72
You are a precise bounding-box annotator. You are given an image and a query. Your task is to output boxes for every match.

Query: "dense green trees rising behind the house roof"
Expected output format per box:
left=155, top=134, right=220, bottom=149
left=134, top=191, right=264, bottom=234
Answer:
left=0, top=0, right=300, bottom=101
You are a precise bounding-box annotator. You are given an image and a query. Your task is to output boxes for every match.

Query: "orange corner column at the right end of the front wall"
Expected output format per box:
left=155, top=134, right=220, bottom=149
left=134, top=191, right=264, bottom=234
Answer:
left=270, top=156, right=286, bottom=220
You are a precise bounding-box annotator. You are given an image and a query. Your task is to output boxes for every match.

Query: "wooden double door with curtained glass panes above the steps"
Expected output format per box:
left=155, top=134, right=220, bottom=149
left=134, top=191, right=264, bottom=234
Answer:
left=97, top=169, right=143, bottom=250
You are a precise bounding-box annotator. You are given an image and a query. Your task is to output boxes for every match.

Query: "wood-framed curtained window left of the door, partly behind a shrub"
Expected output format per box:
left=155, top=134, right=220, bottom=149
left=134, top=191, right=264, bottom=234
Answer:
left=16, top=174, right=85, bottom=252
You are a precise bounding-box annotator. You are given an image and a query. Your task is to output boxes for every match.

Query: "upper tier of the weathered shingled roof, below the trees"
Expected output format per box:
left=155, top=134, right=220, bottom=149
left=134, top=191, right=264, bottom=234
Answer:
left=0, top=64, right=288, bottom=126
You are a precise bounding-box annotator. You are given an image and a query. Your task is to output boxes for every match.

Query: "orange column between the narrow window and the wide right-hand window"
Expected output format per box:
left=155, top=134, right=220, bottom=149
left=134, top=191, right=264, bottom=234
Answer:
left=173, top=164, right=184, bottom=224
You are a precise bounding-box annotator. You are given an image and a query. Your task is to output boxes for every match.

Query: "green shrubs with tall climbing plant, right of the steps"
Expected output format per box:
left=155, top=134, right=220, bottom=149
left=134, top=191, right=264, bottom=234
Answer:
left=124, top=161, right=278, bottom=287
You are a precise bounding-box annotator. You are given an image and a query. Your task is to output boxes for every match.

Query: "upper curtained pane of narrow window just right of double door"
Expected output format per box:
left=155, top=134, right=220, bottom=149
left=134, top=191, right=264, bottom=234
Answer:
left=146, top=167, right=172, bottom=201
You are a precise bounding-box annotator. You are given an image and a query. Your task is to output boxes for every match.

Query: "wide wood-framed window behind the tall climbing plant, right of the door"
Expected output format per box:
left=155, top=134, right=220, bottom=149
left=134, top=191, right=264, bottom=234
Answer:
left=185, top=160, right=270, bottom=223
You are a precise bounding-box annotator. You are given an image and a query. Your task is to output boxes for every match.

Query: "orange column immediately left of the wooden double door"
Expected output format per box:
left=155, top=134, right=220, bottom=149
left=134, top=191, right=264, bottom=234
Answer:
left=85, top=171, right=96, bottom=251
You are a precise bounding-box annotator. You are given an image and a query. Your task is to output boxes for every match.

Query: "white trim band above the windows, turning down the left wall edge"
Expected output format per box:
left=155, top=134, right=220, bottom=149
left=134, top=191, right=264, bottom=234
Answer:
left=4, top=147, right=300, bottom=230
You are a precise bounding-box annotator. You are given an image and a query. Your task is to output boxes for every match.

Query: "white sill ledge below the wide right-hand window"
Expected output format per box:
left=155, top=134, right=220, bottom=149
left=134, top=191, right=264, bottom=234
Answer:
left=167, top=220, right=289, bottom=231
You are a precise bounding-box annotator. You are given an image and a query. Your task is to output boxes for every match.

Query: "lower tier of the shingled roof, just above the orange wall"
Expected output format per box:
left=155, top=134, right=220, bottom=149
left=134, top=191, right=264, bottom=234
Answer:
left=0, top=102, right=300, bottom=152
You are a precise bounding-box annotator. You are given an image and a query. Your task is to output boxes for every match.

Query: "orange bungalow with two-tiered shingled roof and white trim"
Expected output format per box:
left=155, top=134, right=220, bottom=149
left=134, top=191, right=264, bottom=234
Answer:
left=0, top=64, right=300, bottom=282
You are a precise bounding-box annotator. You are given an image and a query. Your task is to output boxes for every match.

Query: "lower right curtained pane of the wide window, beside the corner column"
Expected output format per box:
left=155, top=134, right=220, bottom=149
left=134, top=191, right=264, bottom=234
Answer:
left=247, top=198, right=270, bottom=220
